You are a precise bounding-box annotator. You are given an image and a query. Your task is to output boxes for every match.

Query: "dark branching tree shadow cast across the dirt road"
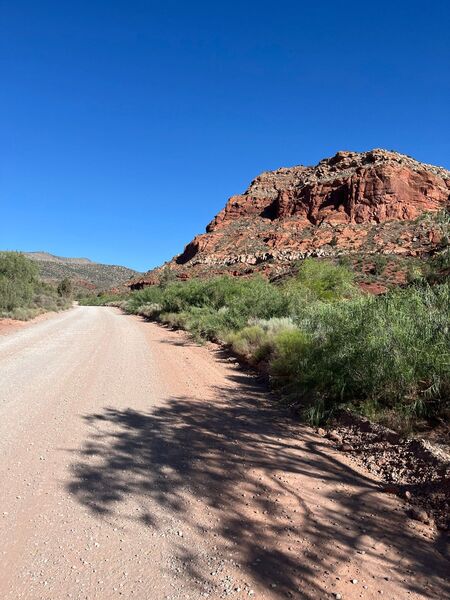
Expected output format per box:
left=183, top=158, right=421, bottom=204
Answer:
left=69, top=372, right=448, bottom=599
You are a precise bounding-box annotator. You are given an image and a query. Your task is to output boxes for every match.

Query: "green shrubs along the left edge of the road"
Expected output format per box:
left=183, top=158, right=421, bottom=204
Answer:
left=0, top=252, right=72, bottom=320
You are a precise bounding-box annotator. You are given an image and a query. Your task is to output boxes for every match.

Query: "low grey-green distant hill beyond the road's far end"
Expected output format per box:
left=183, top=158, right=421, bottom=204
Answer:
left=23, top=252, right=139, bottom=290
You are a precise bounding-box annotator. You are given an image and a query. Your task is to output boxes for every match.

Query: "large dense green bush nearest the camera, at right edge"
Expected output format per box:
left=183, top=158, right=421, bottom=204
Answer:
left=273, top=284, right=450, bottom=424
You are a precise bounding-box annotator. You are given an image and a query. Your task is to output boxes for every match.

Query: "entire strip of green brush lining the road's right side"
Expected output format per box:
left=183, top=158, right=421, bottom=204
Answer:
left=81, top=259, right=450, bottom=430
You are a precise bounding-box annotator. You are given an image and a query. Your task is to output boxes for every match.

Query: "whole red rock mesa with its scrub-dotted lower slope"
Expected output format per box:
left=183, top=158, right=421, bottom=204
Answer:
left=134, top=149, right=450, bottom=278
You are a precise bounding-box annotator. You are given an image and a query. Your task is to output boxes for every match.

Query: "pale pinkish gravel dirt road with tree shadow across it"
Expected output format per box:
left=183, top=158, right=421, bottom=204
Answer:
left=0, top=307, right=449, bottom=600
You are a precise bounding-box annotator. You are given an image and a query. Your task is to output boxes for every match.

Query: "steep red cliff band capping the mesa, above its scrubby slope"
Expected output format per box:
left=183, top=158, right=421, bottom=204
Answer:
left=207, top=150, right=450, bottom=232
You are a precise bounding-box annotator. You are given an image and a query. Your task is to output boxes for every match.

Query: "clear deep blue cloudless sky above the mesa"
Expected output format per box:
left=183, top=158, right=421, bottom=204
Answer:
left=0, top=0, right=450, bottom=270
